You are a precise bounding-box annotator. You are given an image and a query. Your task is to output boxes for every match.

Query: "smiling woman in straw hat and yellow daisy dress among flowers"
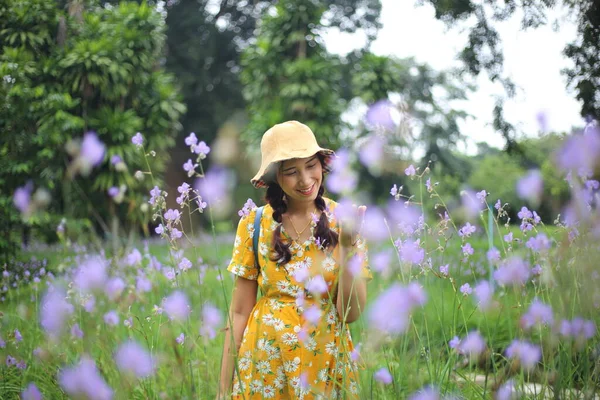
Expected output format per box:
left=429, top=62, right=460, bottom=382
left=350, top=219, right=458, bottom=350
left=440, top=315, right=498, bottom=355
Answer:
left=219, top=121, right=371, bottom=399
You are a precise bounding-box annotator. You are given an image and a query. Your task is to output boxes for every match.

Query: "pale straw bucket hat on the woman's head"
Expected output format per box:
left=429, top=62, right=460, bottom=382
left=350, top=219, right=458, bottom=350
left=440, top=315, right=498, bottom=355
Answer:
left=250, top=121, right=335, bottom=188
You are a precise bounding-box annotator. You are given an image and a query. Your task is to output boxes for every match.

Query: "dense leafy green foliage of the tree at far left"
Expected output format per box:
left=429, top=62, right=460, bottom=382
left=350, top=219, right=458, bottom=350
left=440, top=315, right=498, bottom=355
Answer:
left=0, top=0, right=185, bottom=256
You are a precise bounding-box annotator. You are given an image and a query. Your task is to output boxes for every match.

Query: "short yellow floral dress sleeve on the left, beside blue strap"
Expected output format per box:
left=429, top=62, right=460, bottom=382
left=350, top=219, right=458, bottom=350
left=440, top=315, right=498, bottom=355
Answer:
left=227, top=209, right=258, bottom=280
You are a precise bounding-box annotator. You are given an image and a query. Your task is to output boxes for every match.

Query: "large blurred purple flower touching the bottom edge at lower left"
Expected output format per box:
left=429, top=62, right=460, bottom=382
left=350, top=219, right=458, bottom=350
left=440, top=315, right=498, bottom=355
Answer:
left=58, top=356, right=114, bottom=400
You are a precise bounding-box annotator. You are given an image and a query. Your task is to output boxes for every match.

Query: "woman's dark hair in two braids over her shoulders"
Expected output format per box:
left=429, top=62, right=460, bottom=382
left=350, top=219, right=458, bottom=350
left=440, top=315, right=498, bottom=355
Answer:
left=265, top=157, right=339, bottom=265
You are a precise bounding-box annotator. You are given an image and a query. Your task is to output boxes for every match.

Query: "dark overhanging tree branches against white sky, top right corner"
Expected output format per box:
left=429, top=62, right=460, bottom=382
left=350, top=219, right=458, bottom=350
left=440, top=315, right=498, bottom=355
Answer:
left=419, top=0, right=600, bottom=145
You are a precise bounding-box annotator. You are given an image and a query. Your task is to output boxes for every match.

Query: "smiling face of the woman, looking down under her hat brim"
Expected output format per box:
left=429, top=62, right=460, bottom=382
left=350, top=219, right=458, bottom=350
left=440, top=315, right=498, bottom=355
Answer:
left=277, top=155, right=323, bottom=202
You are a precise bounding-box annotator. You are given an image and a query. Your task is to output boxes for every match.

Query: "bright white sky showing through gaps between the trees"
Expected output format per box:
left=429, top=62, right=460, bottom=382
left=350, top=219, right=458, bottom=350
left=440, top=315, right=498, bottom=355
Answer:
left=324, top=0, right=583, bottom=156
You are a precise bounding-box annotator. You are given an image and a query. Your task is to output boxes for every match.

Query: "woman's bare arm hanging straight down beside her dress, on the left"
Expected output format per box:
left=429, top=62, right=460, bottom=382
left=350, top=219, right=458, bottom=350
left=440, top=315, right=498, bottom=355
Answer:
left=217, top=277, right=258, bottom=398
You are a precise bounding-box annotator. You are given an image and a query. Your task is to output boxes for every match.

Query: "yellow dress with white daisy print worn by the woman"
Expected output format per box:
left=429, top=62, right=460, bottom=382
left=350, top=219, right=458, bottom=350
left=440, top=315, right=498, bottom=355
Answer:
left=227, top=199, right=371, bottom=400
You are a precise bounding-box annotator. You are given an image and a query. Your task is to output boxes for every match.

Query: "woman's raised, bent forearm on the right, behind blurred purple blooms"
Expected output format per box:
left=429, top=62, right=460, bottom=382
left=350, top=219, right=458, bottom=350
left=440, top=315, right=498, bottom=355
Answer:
left=336, top=243, right=367, bottom=324
